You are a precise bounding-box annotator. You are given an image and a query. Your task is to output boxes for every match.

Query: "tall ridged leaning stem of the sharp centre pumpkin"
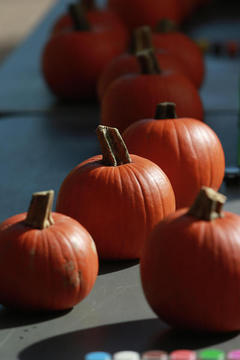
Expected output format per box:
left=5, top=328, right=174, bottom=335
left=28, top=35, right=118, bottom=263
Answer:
left=96, top=125, right=132, bottom=166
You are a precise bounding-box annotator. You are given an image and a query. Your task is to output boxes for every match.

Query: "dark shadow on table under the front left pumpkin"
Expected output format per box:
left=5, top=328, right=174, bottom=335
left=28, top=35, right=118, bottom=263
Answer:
left=0, top=305, right=72, bottom=329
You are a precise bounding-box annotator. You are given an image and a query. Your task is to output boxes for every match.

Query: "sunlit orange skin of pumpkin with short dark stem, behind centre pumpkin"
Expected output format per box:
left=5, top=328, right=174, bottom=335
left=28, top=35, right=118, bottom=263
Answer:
left=123, top=118, right=225, bottom=209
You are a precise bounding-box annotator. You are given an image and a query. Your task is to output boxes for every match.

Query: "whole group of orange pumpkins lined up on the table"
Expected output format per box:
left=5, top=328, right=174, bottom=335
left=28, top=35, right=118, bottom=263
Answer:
left=0, top=0, right=240, bottom=331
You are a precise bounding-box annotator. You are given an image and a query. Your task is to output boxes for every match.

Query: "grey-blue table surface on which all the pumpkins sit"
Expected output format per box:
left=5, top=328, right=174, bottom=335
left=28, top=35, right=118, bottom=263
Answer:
left=0, top=1, right=240, bottom=360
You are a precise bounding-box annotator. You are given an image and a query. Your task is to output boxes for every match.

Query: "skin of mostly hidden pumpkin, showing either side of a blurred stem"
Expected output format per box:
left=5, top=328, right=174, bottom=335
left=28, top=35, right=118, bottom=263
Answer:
left=97, top=51, right=193, bottom=100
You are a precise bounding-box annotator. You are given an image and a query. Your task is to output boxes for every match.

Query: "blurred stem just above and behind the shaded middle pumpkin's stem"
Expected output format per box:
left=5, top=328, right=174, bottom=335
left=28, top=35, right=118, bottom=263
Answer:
left=132, top=26, right=153, bottom=55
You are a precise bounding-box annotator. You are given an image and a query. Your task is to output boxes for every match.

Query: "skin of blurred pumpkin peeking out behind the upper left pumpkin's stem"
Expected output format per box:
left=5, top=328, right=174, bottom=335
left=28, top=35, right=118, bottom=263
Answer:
left=52, top=10, right=129, bottom=54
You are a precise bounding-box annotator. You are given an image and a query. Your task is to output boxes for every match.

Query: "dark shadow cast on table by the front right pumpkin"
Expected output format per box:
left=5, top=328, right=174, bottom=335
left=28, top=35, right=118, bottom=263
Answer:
left=19, top=319, right=238, bottom=360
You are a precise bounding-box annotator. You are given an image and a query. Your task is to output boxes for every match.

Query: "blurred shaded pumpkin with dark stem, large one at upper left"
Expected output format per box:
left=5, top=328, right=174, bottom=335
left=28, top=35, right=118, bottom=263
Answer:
left=41, top=5, right=126, bottom=100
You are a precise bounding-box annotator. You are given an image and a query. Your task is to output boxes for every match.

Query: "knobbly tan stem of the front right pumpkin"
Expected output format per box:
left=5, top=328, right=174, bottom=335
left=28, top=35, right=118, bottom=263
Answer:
left=187, top=186, right=227, bottom=221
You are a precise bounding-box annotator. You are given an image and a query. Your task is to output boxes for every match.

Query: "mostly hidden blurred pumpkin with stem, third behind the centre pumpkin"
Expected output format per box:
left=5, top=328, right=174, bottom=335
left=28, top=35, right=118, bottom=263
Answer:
left=97, top=26, right=195, bottom=100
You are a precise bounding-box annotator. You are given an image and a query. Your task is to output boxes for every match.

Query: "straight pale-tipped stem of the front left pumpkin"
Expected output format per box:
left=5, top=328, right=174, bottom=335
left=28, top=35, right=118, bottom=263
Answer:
left=25, top=190, right=54, bottom=229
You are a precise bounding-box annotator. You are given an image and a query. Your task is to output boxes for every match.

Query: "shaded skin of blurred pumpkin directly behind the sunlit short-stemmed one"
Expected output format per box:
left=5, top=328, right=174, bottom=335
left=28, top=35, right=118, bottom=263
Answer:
left=101, top=72, right=203, bottom=132
